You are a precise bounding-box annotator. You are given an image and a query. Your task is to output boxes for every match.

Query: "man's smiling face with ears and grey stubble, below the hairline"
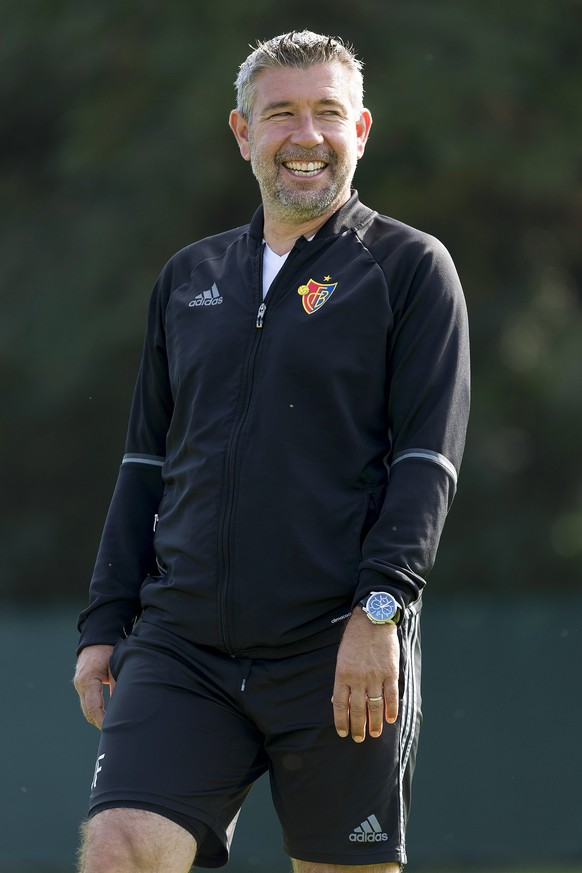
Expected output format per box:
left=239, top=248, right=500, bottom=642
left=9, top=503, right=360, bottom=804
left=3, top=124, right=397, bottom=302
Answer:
left=230, top=63, right=372, bottom=222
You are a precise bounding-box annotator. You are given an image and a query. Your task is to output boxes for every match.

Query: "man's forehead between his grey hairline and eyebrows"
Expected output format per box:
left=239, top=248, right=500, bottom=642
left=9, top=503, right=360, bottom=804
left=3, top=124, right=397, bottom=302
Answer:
left=253, top=63, right=353, bottom=113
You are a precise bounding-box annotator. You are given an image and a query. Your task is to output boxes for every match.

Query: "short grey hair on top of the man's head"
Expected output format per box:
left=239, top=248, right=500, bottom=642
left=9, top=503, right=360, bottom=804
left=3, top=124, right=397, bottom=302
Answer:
left=235, top=30, right=364, bottom=121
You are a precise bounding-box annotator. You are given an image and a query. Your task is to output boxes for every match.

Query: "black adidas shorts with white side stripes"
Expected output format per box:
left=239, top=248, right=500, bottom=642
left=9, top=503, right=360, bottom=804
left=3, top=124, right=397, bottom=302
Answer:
left=89, top=611, right=420, bottom=867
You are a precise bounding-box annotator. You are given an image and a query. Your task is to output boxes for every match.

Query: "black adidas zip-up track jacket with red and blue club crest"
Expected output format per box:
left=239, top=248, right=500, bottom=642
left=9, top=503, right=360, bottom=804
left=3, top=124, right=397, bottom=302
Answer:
left=79, top=192, right=469, bottom=657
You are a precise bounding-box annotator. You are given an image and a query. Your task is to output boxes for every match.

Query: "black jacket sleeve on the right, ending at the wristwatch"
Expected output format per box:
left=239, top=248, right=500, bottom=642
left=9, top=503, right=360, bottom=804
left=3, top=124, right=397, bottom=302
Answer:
left=354, top=237, right=470, bottom=607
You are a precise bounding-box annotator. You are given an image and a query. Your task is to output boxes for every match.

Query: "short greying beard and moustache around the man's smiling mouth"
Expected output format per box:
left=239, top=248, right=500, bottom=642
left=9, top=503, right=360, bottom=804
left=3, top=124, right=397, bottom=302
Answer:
left=251, top=143, right=356, bottom=222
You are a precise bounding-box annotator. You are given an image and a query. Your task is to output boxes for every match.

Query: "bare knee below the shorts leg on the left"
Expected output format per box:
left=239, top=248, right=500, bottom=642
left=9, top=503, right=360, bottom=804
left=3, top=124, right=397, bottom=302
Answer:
left=79, top=809, right=196, bottom=873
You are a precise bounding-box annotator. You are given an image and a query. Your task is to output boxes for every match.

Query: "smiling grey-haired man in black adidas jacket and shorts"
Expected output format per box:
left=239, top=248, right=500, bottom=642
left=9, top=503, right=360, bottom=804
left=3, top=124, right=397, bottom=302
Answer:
left=75, top=31, right=468, bottom=873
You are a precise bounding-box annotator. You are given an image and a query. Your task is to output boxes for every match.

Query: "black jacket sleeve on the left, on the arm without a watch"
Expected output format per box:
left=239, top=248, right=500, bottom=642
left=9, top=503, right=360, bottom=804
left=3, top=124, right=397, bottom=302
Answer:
left=78, top=268, right=173, bottom=651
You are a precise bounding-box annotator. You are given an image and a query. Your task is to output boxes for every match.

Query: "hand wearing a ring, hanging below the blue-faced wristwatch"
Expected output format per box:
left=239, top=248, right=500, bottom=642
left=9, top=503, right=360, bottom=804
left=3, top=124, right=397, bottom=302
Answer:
left=332, top=606, right=400, bottom=743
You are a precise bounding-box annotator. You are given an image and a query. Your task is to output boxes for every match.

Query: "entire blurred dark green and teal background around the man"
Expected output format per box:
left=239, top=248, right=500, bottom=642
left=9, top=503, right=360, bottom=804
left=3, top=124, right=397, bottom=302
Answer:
left=0, top=0, right=582, bottom=873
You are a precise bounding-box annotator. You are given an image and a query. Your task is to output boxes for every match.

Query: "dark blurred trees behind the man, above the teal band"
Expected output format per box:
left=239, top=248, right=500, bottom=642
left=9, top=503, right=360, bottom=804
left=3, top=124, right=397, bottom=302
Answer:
left=0, top=0, right=582, bottom=603
